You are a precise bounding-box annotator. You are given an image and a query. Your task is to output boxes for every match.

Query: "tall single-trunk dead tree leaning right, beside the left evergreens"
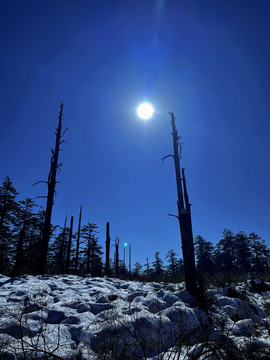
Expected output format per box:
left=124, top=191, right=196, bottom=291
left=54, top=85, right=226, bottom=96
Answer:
left=36, top=103, right=67, bottom=274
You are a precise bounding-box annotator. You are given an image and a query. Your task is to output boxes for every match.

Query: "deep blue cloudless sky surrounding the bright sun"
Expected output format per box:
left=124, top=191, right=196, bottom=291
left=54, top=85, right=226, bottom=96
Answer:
left=0, top=0, right=270, bottom=263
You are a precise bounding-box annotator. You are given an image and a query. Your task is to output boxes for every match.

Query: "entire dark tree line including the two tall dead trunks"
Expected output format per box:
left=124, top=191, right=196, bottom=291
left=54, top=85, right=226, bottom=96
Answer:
left=0, top=106, right=269, bottom=286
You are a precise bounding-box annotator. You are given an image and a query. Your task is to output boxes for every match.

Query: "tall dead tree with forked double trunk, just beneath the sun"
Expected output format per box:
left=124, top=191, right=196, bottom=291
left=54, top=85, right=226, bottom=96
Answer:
left=162, top=112, right=197, bottom=296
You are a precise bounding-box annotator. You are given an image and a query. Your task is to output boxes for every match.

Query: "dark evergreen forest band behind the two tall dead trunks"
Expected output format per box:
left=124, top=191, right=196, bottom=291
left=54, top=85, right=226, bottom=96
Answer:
left=0, top=177, right=270, bottom=282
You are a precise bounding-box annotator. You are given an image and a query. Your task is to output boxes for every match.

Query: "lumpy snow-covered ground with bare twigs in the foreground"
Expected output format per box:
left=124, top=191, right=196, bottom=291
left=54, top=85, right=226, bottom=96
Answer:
left=0, top=275, right=270, bottom=360
